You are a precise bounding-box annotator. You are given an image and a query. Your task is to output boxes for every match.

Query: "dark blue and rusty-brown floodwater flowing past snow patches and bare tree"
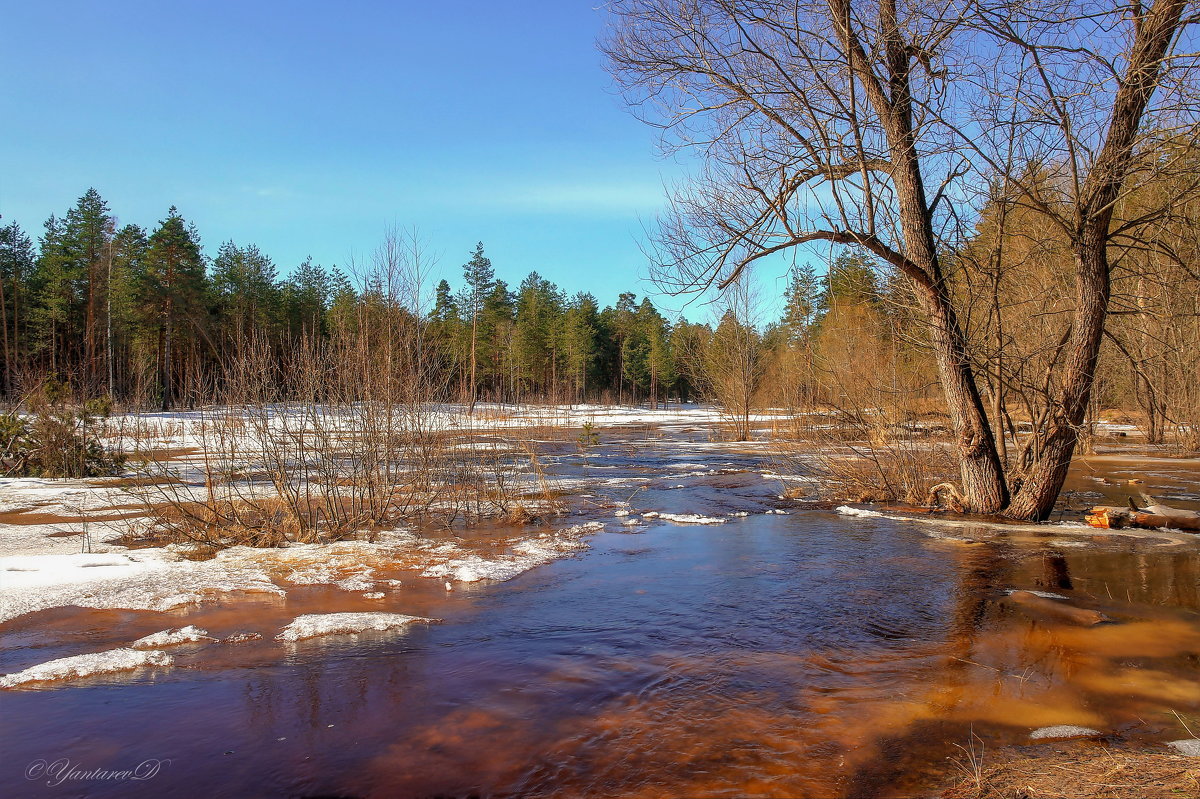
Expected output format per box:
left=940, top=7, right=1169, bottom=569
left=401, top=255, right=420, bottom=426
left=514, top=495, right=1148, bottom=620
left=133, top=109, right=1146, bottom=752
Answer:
left=0, top=437, right=1200, bottom=797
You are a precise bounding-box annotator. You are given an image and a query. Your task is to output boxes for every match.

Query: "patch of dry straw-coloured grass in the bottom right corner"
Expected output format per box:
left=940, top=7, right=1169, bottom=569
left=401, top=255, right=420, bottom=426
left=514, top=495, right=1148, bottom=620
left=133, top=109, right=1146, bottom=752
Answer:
left=940, top=743, right=1200, bottom=799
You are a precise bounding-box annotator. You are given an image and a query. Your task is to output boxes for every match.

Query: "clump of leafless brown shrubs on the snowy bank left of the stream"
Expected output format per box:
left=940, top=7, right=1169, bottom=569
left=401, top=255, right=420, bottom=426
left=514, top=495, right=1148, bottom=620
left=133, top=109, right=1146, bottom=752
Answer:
left=127, top=235, right=556, bottom=548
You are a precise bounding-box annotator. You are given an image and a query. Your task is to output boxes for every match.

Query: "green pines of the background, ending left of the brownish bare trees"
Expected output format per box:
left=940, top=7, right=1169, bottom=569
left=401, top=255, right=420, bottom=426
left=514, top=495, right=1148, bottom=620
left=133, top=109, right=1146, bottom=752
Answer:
left=0, top=188, right=787, bottom=409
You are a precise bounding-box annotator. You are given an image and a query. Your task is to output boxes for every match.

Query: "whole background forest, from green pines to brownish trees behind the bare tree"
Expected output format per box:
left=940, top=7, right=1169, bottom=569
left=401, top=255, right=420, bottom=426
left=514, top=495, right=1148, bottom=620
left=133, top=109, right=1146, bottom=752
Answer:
left=0, top=185, right=1200, bottom=463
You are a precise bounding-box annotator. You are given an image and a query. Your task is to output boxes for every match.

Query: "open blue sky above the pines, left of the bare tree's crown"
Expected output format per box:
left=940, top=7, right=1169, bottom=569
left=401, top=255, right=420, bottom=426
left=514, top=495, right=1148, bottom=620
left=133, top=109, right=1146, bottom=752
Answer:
left=0, top=0, right=782, bottom=317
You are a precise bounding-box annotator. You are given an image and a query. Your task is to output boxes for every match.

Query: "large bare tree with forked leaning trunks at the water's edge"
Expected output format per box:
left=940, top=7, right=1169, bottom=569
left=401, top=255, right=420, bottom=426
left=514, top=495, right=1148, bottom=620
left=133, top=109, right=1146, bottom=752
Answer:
left=604, top=0, right=1192, bottom=518
